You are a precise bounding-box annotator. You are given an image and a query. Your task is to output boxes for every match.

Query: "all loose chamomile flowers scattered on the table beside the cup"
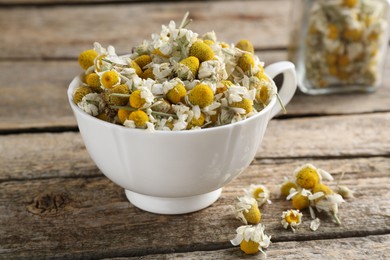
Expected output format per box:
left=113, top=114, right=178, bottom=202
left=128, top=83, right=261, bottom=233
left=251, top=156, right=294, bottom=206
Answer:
left=230, top=163, right=354, bottom=255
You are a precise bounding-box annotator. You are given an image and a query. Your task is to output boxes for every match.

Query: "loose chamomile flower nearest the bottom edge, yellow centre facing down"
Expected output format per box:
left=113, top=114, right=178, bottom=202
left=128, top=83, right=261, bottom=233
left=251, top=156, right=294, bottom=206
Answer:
left=230, top=224, right=271, bottom=254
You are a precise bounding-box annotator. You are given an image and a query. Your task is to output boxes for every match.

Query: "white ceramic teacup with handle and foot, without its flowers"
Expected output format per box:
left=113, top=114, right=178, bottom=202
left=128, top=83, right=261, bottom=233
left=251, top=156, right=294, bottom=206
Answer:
left=68, top=61, right=297, bottom=214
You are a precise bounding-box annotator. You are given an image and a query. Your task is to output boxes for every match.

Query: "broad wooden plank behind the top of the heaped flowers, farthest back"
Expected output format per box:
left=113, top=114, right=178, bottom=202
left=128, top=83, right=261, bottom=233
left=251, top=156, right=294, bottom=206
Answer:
left=0, top=0, right=291, bottom=59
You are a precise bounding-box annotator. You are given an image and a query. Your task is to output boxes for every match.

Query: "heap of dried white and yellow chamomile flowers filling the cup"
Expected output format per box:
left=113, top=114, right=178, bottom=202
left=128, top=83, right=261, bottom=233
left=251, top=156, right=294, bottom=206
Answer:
left=73, top=13, right=277, bottom=131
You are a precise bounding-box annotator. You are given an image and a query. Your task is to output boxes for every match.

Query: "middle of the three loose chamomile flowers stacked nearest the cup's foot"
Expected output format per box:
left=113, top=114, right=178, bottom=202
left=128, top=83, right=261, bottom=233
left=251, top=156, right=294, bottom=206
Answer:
left=234, top=196, right=261, bottom=224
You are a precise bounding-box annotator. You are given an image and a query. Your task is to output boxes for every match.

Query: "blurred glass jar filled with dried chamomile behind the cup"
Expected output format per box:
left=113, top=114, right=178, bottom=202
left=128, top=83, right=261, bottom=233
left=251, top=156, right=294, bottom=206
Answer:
left=289, top=0, right=390, bottom=94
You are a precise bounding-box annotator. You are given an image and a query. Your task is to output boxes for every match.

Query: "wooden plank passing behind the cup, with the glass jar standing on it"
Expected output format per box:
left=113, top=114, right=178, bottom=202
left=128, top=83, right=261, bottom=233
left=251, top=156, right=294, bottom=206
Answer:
left=0, top=51, right=390, bottom=132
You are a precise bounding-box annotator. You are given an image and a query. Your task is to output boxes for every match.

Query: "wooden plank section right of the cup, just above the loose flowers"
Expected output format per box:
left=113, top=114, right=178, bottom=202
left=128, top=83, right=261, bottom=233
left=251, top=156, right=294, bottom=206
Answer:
left=257, top=113, right=390, bottom=158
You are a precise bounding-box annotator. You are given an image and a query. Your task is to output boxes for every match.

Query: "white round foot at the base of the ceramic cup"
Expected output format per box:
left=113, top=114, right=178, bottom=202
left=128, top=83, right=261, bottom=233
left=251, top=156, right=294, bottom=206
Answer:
left=125, top=189, right=222, bottom=215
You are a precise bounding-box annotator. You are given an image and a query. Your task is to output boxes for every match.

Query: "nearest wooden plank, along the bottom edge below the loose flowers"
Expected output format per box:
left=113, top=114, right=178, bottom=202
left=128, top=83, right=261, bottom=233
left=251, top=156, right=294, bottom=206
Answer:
left=125, top=235, right=390, bottom=260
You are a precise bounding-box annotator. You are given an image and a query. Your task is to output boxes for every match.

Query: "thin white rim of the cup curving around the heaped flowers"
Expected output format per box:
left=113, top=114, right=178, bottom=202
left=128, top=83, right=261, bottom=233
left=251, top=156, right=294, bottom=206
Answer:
left=67, top=72, right=276, bottom=135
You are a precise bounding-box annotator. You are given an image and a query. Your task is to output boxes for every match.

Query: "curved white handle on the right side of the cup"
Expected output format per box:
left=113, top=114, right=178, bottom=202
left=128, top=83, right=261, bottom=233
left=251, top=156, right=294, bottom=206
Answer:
left=264, top=61, right=297, bottom=119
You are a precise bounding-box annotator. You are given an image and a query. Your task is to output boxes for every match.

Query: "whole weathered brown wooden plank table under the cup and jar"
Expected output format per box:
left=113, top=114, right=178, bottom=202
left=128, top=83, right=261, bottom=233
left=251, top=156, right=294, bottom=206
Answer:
left=0, top=0, right=390, bottom=259
